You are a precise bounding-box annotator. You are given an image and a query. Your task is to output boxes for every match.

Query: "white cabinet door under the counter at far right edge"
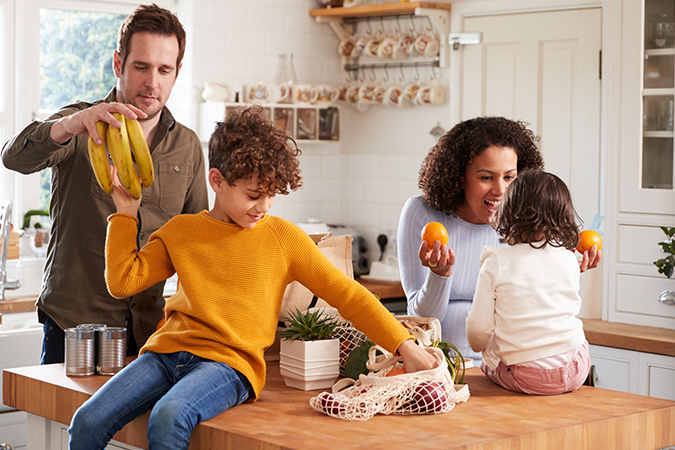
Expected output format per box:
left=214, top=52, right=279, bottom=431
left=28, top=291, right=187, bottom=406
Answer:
left=638, top=353, right=675, bottom=400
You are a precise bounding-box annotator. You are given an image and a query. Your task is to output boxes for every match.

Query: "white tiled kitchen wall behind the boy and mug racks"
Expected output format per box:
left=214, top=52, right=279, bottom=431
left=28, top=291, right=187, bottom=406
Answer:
left=182, top=0, right=451, bottom=257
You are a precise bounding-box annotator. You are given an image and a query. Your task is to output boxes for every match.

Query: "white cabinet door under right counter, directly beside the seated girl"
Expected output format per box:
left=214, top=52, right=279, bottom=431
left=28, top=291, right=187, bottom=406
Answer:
left=589, top=345, right=638, bottom=394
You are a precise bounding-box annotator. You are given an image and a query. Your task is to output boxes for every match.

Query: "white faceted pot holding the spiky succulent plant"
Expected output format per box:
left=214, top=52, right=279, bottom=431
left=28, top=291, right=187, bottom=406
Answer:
left=279, top=338, right=340, bottom=391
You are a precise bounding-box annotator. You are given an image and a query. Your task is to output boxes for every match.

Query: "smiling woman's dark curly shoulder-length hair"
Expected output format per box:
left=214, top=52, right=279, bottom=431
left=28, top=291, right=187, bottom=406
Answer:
left=419, top=117, right=544, bottom=214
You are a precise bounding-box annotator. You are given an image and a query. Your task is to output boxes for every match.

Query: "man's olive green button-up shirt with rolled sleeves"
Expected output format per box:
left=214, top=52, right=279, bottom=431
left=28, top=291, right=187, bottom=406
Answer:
left=2, top=89, right=208, bottom=348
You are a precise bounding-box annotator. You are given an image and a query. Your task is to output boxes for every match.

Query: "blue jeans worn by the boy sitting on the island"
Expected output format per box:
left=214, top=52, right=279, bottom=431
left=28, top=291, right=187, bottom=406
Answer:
left=68, top=352, right=253, bottom=450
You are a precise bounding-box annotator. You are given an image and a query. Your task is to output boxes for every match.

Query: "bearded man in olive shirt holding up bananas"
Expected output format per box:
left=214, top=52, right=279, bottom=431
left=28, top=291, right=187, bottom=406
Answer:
left=2, top=4, right=208, bottom=364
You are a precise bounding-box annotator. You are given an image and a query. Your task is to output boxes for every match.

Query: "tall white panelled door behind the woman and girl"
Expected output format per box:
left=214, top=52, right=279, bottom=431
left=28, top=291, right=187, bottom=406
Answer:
left=461, top=8, right=604, bottom=317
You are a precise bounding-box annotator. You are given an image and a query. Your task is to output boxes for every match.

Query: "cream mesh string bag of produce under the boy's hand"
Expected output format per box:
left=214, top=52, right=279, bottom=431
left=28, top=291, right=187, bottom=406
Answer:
left=309, top=346, right=470, bottom=420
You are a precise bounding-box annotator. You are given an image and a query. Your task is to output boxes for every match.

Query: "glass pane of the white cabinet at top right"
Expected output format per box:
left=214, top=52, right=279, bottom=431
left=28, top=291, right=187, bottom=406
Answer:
left=641, top=0, right=675, bottom=189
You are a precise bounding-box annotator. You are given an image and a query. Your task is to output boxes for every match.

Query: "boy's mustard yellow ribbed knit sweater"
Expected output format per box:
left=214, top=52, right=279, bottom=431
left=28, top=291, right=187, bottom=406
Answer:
left=105, top=211, right=411, bottom=398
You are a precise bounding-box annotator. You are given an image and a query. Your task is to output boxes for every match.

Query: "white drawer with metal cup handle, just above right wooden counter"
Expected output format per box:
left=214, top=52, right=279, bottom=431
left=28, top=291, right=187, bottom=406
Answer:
left=616, top=273, right=675, bottom=318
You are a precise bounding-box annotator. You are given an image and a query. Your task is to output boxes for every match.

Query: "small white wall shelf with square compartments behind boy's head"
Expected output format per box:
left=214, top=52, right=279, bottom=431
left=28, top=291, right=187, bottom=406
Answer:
left=198, top=102, right=340, bottom=143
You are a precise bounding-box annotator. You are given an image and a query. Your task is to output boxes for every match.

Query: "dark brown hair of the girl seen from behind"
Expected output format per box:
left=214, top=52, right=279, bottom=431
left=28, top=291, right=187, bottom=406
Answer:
left=491, top=170, right=581, bottom=250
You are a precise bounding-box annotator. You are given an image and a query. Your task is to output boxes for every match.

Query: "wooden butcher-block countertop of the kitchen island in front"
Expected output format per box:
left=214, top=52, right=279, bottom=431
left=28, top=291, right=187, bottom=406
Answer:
left=3, top=356, right=675, bottom=450
